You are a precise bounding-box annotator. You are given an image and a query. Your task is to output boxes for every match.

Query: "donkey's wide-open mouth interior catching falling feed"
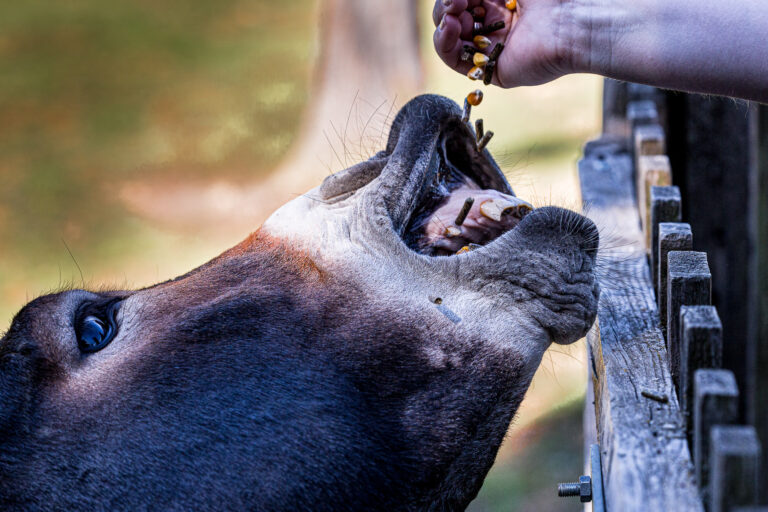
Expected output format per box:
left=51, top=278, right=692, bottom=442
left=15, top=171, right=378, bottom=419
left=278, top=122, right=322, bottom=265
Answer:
left=403, top=118, right=533, bottom=256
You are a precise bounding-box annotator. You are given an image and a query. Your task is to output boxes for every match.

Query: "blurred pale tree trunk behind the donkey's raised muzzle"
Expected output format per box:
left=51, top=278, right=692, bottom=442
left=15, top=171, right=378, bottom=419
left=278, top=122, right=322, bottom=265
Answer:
left=273, top=0, right=423, bottom=186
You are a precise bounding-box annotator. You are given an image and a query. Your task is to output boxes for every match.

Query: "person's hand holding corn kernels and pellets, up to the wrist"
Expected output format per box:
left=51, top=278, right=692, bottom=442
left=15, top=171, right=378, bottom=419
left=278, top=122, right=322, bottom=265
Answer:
left=432, top=0, right=589, bottom=88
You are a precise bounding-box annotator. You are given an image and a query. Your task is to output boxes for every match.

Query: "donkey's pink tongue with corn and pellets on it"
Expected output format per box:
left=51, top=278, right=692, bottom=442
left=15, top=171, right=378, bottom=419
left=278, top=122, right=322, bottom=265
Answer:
left=424, top=183, right=533, bottom=254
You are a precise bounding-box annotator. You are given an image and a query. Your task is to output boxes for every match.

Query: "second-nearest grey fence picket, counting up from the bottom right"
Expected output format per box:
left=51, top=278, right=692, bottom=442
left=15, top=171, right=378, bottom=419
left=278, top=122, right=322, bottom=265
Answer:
left=692, top=369, right=739, bottom=501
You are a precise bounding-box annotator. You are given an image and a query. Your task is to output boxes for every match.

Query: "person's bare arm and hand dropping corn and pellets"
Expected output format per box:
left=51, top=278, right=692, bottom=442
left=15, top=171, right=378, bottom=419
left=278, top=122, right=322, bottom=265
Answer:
left=433, top=0, right=768, bottom=103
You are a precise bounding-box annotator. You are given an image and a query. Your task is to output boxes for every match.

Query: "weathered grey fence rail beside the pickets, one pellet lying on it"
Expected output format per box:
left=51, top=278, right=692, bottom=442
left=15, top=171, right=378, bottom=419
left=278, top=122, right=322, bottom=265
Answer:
left=579, top=136, right=703, bottom=512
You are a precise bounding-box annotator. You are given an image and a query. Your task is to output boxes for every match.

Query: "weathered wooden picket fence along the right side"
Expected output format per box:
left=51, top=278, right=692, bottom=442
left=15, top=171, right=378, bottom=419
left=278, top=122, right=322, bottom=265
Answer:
left=579, top=80, right=768, bottom=512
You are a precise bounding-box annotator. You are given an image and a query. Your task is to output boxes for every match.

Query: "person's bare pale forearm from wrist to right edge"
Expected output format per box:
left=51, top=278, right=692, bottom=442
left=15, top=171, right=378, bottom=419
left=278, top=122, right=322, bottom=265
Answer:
left=570, top=0, right=768, bottom=102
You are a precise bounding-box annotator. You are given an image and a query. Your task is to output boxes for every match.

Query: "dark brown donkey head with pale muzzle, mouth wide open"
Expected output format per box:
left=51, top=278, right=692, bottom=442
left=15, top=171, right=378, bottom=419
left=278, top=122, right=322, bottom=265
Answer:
left=0, top=96, right=598, bottom=510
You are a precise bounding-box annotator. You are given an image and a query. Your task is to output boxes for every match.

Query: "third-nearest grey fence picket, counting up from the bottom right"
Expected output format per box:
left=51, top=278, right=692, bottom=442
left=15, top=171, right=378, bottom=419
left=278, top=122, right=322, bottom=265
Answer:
left=678, top=306, right=724, bottom=443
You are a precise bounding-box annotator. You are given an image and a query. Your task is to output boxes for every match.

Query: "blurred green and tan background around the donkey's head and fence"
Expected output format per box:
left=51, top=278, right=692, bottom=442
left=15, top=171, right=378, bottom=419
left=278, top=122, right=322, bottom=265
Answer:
left=0, top=0, right=600, bottom=511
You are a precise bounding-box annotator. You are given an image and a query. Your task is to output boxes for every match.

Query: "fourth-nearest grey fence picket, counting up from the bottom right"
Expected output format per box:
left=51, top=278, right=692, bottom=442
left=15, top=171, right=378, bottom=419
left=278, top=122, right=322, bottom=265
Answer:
left=667, top=251, right=712, bottom=391
